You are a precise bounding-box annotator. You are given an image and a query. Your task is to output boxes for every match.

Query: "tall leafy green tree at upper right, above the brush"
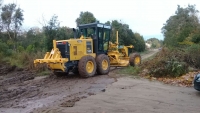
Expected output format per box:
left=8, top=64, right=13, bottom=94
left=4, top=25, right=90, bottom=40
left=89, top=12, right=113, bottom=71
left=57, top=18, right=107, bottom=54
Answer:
left=162, top=5, right=199, bottom=46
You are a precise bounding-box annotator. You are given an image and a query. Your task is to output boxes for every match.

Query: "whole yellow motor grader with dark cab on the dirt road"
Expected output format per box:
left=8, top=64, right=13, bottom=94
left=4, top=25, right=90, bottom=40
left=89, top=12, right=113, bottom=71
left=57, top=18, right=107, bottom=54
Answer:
left=34, top=22, right=141, bottom=77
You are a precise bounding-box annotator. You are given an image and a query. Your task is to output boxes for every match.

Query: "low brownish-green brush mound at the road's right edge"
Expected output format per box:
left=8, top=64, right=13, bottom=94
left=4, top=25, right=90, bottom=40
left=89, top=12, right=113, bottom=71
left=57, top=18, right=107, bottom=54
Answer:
left=141, top=45, right=200, bottom=77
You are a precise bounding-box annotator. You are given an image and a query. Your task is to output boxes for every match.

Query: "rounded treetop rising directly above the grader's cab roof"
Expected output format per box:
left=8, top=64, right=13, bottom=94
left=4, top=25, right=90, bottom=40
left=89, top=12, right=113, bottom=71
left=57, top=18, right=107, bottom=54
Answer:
left=76, top=11, right=97, bottom=26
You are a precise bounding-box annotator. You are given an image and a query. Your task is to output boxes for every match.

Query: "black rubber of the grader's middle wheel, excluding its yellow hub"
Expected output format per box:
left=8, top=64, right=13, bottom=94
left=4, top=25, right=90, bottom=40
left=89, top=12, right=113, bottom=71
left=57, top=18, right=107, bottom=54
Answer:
left=96, top=54, right=110, bottom=75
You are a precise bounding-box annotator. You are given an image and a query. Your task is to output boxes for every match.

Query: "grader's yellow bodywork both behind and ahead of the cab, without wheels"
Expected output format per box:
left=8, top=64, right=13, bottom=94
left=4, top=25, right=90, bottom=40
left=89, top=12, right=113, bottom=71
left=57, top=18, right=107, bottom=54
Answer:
left=34, top=31, right=134, bottom=71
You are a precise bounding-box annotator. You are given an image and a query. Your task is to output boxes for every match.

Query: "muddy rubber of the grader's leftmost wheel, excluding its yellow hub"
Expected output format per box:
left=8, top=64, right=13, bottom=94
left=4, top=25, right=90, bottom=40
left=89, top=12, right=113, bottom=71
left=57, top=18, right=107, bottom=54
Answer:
left=78, top=55, right=96, bottom=78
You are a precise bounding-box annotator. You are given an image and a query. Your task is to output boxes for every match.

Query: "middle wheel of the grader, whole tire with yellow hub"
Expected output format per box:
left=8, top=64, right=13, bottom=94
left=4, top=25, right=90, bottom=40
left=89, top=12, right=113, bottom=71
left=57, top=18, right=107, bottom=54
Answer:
left=96, top=54, right=110, bottom=75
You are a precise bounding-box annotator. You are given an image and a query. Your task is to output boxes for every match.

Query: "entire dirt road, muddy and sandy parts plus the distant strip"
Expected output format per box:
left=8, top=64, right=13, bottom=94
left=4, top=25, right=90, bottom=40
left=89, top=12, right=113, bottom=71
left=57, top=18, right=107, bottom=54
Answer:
left=0, top=48, right=200, bottom=113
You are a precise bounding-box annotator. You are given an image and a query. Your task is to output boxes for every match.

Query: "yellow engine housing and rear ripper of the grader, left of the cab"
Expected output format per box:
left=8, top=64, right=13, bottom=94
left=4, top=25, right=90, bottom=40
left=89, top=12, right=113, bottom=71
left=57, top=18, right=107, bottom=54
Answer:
left=34, top=39, right=96, bottom=72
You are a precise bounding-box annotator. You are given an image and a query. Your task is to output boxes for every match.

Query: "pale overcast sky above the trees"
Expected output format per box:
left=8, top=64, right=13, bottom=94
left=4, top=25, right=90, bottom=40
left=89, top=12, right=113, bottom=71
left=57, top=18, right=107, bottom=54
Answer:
left=4, top=0, right=200, bottom=39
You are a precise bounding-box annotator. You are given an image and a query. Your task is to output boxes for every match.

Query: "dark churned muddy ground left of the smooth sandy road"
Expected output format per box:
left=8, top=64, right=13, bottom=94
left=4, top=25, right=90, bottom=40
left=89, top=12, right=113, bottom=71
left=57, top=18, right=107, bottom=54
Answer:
left=0, top=75, right=116, bottom=113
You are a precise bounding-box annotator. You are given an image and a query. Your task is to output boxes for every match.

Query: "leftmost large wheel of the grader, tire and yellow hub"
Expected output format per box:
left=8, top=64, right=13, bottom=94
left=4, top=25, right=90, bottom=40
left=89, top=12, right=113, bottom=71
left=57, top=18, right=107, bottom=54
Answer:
left=78, top=55, right=97, bottom=78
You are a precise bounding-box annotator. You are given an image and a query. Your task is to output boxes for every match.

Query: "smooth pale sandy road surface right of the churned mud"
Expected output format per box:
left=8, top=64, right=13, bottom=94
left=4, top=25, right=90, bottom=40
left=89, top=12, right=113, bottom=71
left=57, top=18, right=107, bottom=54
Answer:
left=62, top=78, right=200, bottom=113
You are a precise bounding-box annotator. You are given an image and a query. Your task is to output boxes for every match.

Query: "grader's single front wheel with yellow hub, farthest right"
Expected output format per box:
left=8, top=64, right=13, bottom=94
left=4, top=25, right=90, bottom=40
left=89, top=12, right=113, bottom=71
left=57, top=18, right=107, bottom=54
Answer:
left=129, top=53, right=141, bottom=66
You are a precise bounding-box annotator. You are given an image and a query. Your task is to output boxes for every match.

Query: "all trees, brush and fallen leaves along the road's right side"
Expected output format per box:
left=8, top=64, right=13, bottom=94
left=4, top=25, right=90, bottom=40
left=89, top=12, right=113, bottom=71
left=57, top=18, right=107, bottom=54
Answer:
left=121, top=5, right=200, bottom=86
